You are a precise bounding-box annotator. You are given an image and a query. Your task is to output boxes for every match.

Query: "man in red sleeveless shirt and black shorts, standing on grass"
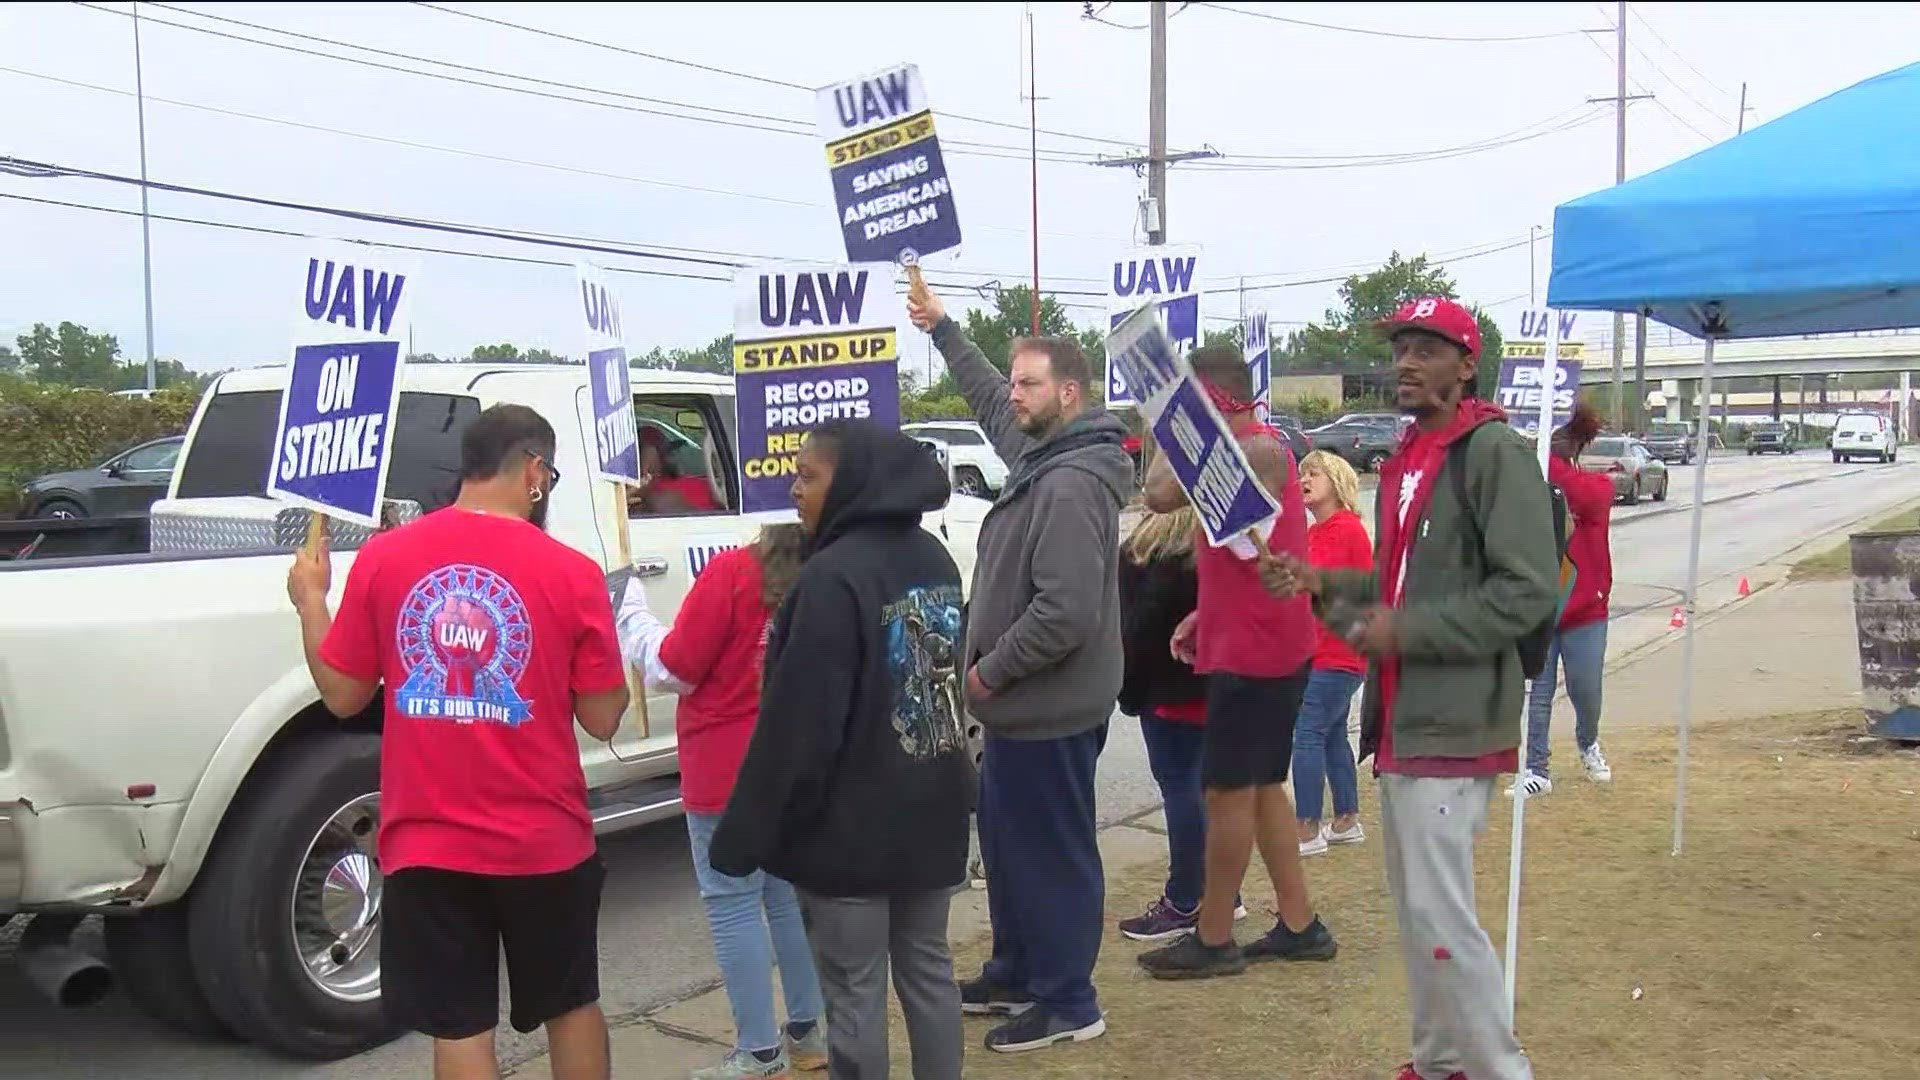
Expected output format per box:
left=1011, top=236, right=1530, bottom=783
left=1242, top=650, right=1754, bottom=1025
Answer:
left=1139, top=346, right=1338, bottom=978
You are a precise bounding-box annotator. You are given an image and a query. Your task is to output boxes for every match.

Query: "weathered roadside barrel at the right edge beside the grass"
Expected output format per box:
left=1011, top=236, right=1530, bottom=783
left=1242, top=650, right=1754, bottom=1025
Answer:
left=1847, top=528, right=1920, bottom=740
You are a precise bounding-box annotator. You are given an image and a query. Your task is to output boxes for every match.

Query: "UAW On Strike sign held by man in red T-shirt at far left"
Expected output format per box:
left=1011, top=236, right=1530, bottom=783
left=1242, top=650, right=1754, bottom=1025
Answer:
left=267, top=244, right=413, bottom=528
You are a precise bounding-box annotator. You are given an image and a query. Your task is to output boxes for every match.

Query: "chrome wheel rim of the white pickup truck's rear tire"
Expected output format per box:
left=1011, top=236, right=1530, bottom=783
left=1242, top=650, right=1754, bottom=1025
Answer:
left=292, top=794, right=384, bottom=1001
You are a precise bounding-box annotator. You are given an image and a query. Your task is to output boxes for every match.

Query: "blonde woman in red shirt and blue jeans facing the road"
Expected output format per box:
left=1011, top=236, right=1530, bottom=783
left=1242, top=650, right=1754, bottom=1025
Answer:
left=1294, top=450, right=1373, bottom=855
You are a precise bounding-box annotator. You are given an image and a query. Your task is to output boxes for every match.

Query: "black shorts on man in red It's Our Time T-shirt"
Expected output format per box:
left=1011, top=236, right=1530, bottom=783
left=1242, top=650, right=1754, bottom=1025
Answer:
left=380, top=855, right=607, bottom=1040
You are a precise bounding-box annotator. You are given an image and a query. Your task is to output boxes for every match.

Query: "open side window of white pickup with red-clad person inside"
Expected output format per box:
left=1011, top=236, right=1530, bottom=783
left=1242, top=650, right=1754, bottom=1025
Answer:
left=628, top=394, right=739, bottom=517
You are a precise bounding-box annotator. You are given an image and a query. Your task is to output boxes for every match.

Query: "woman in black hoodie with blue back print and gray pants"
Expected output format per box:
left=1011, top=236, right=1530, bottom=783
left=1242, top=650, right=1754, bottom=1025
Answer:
left=710, top=423, right=972, bottom=1080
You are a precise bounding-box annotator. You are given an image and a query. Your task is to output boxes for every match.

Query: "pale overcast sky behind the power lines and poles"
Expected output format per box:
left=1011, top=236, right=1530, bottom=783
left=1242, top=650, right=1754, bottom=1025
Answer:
left=0, top=2, right=1920, bottom=369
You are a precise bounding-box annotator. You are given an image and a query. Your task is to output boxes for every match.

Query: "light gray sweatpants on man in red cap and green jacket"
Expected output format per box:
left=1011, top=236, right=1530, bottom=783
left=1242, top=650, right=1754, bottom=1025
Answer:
left=1380, top=774, right=1532, bottom=1080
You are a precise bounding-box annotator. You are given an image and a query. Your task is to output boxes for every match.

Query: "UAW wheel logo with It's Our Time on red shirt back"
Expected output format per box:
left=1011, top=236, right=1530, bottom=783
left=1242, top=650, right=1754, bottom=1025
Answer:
left=394, top=565, right=534, bottom=726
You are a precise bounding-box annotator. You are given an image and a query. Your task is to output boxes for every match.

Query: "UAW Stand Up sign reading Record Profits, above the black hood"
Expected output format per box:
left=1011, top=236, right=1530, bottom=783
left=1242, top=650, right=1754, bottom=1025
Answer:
left=733, top=263, right=900, bottom=517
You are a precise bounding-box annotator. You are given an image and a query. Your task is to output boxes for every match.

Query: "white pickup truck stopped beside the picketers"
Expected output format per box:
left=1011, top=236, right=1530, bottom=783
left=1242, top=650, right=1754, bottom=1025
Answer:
left=0, top=363, right=987, bottom=1059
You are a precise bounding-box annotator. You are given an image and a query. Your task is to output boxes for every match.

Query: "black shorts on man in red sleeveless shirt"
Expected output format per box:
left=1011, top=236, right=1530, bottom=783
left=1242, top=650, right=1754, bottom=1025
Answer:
left=1200, top=667, right=1311, bottom=790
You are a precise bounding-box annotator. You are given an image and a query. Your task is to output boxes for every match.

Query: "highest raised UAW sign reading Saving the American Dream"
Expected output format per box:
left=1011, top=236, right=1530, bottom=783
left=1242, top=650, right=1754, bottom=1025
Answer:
left=816, top=63, right=960, bottom=263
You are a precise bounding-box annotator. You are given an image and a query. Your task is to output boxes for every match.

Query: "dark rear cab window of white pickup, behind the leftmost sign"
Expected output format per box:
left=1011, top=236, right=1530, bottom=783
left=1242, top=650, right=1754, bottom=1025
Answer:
left=179, top=390, right=480, bottom=511
